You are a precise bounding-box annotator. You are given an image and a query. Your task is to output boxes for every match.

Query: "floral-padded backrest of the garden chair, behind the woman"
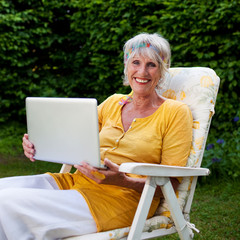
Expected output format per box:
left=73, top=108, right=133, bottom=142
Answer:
left=158, top=67, right=220, bottom=217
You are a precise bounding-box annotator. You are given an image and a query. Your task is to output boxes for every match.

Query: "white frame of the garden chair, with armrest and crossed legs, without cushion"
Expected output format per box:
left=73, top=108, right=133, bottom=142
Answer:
left=60, top=68, right=220, bottom=240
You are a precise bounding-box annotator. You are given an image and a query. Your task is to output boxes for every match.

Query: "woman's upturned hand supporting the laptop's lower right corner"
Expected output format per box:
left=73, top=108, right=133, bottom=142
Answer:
left=74, top=158, right=126, bottom=186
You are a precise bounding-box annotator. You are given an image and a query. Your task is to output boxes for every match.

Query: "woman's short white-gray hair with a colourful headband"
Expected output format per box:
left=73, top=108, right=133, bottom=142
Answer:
left=123, top=33, right=171, bottom=88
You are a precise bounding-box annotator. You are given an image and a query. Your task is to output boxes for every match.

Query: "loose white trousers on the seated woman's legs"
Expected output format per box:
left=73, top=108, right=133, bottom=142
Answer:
left=0, top=174, right=97, bottom=240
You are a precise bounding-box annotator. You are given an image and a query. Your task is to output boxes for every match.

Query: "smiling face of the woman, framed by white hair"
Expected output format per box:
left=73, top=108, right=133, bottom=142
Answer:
left=127, top=55, right=161, bottom=96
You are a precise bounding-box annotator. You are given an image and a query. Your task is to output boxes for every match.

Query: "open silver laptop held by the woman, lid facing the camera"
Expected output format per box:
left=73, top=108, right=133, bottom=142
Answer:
left=26, top=97, right=104, bottom=168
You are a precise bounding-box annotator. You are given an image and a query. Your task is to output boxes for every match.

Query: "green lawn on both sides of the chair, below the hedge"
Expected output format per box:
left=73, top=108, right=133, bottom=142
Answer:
left=0, top=122, right=240, bottom=240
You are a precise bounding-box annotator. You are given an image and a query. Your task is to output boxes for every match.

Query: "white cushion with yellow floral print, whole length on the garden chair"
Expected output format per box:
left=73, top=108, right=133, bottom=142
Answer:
left=64, top=67, right=220, bottom=240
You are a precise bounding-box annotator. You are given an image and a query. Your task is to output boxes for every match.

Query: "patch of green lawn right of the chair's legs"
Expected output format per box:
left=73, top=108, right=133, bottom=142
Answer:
left=158, top=181, right=240, bottom=240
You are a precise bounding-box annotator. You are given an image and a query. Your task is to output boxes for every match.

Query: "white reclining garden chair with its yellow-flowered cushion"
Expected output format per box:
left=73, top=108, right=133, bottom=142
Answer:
left=61, top=67, right=220, bottom=240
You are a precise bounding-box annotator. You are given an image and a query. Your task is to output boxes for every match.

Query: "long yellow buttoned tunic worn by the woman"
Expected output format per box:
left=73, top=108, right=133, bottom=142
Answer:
left=49, top=94, right=192, bottom=231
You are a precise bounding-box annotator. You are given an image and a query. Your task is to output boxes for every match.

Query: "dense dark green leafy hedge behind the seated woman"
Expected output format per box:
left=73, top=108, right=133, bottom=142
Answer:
left=0, top=0, right=240, bottom=178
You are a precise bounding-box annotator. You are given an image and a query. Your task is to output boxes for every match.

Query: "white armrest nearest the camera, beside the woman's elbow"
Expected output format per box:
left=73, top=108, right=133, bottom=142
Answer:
left=119, top=163, right=210, bottom=177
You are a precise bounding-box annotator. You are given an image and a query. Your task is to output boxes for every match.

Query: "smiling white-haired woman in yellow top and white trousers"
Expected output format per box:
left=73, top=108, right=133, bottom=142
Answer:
left=0, top=33, right=192, bottom=240
